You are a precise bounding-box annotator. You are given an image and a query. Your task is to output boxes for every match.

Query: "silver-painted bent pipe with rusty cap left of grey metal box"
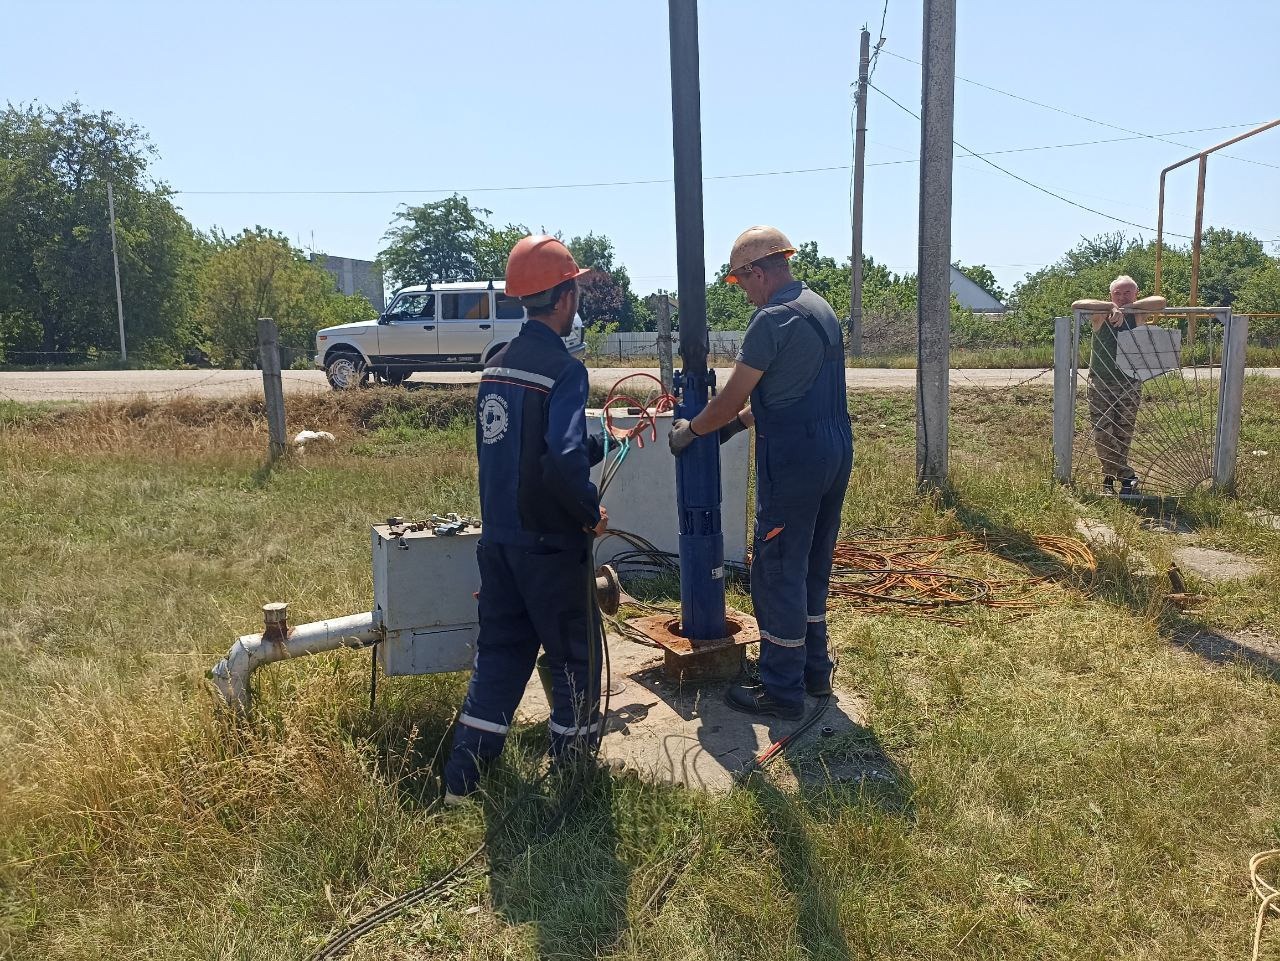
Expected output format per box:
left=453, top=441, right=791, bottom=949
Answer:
left=209, top=604, right=383, bottom=713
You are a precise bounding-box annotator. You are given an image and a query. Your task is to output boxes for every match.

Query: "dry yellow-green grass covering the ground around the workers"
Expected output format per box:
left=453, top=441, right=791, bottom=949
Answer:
left=0, top=384, right=1280, bottom=961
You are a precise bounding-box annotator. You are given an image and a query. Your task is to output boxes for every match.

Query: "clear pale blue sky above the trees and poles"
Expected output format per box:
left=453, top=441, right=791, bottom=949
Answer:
left=0, top=0, right=1280, bottom=293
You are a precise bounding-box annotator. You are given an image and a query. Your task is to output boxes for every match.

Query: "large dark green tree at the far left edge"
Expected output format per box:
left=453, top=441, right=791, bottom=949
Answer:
left=0, top=101, right=198, bottom=352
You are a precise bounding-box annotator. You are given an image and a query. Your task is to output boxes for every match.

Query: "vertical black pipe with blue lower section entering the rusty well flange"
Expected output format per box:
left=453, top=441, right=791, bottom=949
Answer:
left=668, top=0, right=728, bottom=647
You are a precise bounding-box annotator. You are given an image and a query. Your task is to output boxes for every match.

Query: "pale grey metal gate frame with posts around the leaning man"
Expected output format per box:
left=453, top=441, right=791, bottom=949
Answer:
left=1053, top=307, right=1249, bottom=494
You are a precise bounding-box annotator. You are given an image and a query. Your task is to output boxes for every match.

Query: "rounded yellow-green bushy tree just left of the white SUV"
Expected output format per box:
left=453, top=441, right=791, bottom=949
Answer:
left=196, top=226, right=376, bottom=363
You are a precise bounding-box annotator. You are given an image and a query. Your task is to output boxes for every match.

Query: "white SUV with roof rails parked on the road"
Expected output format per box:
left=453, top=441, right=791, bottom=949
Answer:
left=316, top=280, right=586, bottom=390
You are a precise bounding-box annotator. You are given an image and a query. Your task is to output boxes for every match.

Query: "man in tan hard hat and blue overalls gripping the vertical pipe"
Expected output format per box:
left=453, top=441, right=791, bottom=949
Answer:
left=668, top=226, right=854, bottom=720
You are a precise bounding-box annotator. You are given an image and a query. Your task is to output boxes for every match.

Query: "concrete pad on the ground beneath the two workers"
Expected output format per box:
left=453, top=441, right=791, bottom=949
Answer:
left=520, top=635, right=875, bottom=792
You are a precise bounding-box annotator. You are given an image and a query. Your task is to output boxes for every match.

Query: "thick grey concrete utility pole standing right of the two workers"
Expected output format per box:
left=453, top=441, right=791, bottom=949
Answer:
left=915, top=0, right=956, bottom=486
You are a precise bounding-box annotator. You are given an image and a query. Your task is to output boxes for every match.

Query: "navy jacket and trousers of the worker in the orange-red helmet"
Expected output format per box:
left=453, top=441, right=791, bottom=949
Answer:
left=444, top=320, right=603, bottom=795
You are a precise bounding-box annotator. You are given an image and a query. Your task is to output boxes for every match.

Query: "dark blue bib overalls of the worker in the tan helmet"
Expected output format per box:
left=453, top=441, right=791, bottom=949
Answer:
left=751, top=288, right=854, bottom=705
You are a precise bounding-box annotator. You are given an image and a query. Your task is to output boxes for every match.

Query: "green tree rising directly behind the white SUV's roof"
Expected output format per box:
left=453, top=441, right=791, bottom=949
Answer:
left=378, top=193, right=494, bottom=288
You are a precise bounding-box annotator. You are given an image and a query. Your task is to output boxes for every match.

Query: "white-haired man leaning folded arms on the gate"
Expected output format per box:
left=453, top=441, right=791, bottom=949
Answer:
left=1071, top=274, right=1167, bottom=494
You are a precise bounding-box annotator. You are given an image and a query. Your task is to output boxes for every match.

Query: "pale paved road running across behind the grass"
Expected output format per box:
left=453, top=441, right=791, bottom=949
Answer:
left=0, top=367, right=1280, bottom=402
